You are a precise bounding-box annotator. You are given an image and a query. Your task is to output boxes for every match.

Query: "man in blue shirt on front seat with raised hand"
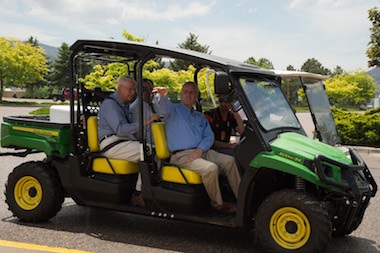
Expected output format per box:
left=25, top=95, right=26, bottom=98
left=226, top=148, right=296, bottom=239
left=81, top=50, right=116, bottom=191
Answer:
left=160, top=82, right=240, bottom=213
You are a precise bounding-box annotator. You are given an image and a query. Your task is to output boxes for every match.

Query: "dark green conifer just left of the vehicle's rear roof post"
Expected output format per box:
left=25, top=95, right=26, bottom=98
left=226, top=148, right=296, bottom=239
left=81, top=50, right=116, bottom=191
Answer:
left=48, top=42, right=71, bottom=88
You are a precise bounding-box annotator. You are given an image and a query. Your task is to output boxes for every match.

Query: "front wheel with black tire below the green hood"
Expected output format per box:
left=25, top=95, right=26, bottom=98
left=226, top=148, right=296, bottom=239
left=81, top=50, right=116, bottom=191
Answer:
left=255, top=189, right=332, bottom=252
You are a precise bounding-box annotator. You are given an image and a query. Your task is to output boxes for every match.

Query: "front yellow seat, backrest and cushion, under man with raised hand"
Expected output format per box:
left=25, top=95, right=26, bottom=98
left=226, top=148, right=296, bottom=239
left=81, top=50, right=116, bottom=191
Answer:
left=152, top=122, right=202, bottom=184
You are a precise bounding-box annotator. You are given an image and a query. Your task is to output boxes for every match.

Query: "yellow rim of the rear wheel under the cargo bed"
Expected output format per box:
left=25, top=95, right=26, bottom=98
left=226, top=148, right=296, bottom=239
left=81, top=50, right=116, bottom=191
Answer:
left=14, top=176, right=42, bottom=210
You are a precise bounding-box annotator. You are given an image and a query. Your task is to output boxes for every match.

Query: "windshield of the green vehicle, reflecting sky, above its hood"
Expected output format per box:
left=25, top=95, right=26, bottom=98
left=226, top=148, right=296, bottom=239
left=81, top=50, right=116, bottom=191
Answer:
left=240, top=78, right=301, bottom=131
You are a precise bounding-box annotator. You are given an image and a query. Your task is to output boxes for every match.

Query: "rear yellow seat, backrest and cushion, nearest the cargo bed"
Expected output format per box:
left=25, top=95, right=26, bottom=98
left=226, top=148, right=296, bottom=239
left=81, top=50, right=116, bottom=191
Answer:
left=87, top=116, right=139, bottom=175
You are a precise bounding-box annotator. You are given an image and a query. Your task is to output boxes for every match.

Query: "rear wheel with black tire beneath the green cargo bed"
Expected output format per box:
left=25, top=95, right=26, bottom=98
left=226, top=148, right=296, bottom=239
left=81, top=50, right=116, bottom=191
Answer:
left=5, top=162, right=64, bottom=222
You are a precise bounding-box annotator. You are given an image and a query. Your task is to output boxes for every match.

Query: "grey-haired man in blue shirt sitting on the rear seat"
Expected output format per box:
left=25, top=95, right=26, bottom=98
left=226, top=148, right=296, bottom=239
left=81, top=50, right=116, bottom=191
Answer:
left=98, top=75, right=160, bottom=206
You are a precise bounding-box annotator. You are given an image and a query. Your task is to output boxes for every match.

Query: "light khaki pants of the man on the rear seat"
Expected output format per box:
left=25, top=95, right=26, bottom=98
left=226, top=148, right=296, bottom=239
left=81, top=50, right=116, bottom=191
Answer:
left=99, top=135, right=142, bottom=191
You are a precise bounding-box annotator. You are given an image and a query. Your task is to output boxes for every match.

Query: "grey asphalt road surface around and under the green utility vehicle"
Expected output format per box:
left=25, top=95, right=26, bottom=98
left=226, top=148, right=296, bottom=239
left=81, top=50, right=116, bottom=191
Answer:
left=0, top=106, right=380, bottom=253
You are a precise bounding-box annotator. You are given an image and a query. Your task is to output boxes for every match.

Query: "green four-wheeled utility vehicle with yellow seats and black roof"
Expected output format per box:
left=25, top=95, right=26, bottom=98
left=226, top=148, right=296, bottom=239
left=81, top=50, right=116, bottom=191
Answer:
left=1, top=40, right=377, bottom=252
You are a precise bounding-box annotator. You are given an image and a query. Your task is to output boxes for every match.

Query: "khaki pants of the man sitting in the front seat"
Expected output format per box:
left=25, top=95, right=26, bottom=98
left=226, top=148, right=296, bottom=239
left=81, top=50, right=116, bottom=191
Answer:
left=170, top=149, right=240, bottom=209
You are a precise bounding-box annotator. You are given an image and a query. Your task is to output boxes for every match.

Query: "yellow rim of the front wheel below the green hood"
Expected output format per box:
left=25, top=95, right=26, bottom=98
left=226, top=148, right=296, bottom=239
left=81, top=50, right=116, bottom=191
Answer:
left=269, top=207, right=311, bottom=250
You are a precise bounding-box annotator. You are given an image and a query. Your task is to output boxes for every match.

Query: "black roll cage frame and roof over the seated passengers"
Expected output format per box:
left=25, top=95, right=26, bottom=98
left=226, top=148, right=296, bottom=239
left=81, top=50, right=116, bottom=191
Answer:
left=70, top=40, right=305, bottom=154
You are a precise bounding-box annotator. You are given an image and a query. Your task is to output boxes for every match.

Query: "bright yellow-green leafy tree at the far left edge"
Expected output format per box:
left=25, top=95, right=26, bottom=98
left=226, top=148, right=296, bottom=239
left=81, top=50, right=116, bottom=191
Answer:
left=0, top=37, right=48, bottom=99
